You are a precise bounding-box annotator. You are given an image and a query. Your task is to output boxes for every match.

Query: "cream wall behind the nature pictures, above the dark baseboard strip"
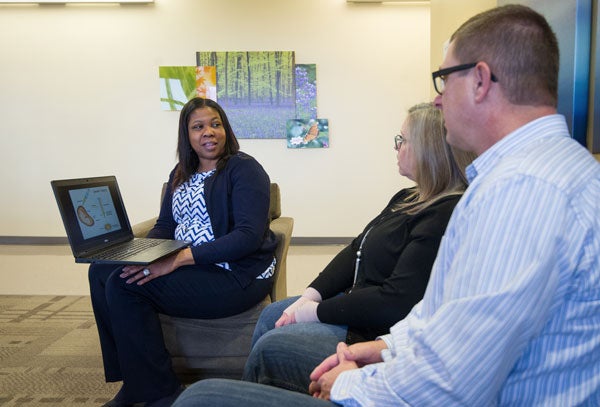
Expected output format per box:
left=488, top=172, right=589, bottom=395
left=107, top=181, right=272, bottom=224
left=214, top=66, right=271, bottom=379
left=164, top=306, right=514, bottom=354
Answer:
left=0, top=0, right=431, bottom=236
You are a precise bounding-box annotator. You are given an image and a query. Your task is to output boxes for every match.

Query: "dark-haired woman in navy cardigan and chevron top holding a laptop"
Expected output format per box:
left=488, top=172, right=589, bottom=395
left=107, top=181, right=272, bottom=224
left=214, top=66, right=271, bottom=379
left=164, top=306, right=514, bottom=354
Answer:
left=89, top=98, right=277, bottom=407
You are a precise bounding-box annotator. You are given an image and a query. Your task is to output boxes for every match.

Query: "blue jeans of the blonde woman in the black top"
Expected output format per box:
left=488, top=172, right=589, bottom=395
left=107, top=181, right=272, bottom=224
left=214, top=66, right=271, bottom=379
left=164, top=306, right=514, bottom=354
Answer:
left=242, top=297, right=348, bottom=393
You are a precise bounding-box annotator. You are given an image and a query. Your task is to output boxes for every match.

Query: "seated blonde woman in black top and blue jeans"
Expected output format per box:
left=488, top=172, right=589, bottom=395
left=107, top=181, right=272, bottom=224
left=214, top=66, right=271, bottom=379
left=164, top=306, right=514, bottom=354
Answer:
left=243, top=103, right=473, bottom=392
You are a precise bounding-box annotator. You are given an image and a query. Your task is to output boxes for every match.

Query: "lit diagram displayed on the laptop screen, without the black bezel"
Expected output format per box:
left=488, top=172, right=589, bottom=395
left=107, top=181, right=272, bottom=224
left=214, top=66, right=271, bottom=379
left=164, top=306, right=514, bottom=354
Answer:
left=69, top=186, right=121, bottom=240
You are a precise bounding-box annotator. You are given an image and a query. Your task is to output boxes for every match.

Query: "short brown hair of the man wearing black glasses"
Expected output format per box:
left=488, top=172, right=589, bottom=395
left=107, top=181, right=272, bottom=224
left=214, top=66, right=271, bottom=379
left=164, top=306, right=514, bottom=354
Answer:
left=450, top=5, right=559, bottom=107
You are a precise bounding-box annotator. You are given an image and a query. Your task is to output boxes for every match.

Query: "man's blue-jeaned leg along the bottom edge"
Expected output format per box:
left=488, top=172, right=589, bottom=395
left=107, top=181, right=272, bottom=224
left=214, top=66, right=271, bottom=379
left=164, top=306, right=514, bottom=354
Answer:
left=173, top=379, right=339, bottom=407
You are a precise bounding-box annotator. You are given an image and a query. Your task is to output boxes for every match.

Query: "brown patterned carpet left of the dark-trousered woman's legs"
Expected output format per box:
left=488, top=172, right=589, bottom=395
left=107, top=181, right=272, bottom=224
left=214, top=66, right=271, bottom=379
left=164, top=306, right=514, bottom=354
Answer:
left=0, top=295, right=120, bottom=407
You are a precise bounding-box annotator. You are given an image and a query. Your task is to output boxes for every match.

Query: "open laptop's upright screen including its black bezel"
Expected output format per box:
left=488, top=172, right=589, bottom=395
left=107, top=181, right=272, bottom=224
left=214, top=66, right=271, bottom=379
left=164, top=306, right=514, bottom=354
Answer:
left=51, top=176, right=133, bottom=257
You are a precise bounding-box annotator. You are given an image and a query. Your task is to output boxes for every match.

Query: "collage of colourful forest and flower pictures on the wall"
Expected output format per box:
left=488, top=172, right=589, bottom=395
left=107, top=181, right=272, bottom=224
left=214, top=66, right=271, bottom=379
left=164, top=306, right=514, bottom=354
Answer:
left=159, top=51, right=329, bottom=149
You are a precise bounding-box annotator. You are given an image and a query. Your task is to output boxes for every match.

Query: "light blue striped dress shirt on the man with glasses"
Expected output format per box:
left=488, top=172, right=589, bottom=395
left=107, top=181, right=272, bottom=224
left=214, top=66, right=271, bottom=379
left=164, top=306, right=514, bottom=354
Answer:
left=331, top=115, right=600, bottom=407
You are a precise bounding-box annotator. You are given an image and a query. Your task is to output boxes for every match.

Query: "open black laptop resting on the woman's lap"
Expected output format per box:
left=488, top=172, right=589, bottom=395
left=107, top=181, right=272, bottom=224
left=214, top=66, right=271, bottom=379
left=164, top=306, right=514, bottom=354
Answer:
left=50, top=176, right=189, bottom=265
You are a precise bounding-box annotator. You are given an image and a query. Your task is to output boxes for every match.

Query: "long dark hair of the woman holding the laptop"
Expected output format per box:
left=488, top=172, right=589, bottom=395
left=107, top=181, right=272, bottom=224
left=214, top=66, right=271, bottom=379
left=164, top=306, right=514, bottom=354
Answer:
left=173, top=97, right=240, bottom=189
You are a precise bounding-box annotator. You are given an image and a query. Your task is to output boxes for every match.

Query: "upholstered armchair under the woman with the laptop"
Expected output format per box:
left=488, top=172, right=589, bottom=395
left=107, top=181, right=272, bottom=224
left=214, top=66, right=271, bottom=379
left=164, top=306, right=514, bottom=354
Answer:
left=133, top=183, right=294, bottom=383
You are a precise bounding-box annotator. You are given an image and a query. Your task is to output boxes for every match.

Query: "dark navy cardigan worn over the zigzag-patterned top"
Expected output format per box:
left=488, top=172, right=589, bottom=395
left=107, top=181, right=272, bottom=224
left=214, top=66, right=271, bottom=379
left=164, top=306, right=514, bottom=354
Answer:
left=148, top=152, right=277, bottom=287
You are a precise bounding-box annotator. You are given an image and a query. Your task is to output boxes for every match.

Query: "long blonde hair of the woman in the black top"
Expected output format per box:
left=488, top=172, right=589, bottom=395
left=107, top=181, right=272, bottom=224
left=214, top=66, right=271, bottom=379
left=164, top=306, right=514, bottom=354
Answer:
left=398, top=103, right=475, bottom=214
